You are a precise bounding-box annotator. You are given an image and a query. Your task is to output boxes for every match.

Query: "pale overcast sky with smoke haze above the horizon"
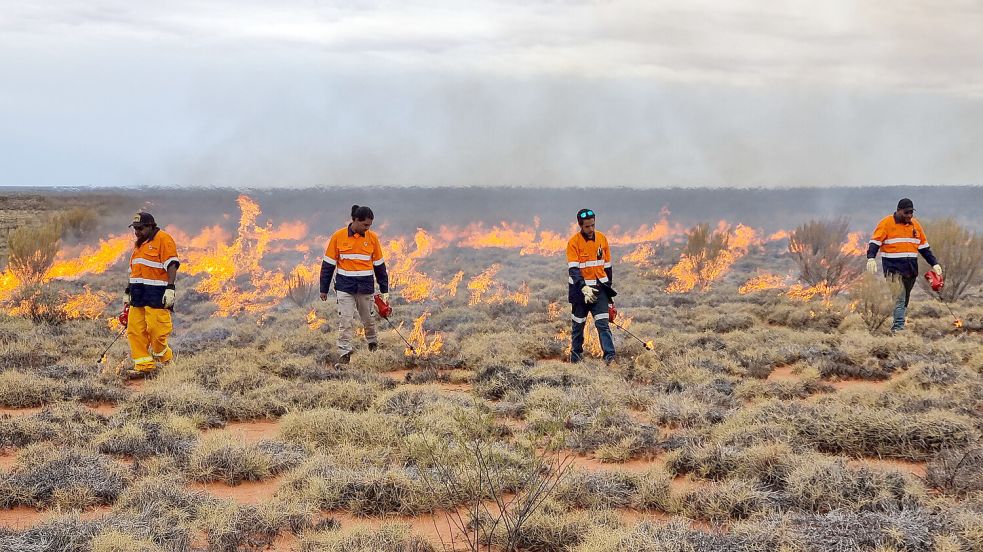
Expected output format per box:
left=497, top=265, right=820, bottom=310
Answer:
left=0, top=0, right=983, bottom=187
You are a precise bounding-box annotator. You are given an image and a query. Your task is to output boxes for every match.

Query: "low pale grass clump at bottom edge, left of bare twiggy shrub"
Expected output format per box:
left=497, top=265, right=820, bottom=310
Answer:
left=300, top=523, right=437, bottom=552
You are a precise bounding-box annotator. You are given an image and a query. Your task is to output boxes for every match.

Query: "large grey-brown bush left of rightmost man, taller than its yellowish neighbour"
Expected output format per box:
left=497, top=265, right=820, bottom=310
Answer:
left=788, top=218, right=860, bottom=293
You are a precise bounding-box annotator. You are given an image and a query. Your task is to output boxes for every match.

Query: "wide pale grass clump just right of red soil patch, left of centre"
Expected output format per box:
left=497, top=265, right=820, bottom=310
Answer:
left=280, top=408, right=401, bottom=449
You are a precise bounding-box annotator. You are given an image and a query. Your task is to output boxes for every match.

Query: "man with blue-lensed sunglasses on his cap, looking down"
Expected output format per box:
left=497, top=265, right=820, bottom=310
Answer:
left=567, top=209, right=615, bottom=364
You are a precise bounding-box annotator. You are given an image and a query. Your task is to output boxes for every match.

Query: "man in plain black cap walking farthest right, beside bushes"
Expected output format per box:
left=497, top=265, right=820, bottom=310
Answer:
left=867, top=198, right=942, bottom=332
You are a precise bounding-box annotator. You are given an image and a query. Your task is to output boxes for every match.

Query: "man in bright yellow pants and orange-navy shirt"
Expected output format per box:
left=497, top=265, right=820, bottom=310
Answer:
left=123, top=213, right=181, bottom=377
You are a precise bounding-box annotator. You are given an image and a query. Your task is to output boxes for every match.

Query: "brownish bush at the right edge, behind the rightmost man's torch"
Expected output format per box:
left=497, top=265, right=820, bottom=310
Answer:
left=919, top=218, right=983, bottom=301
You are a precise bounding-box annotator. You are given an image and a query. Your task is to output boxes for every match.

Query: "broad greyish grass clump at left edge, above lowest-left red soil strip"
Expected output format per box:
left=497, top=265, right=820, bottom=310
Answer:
left=0, top=445, right=129, bottom=508
